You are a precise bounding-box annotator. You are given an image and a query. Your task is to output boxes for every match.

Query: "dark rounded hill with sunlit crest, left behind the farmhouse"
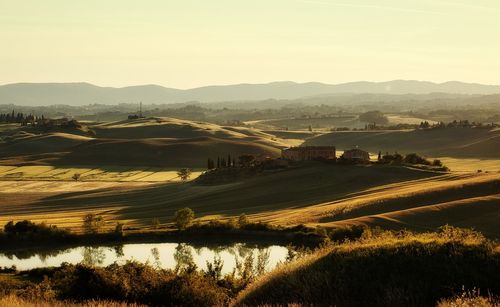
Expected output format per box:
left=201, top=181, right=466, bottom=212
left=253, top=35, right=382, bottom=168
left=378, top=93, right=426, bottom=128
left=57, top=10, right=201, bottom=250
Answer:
left=0, top=118, right=287, bottom=167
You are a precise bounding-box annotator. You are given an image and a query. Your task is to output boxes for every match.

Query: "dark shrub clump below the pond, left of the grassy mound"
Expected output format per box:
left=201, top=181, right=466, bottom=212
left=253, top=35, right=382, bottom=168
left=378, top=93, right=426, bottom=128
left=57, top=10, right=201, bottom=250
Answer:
left=51, top=262, right=229, bottom=306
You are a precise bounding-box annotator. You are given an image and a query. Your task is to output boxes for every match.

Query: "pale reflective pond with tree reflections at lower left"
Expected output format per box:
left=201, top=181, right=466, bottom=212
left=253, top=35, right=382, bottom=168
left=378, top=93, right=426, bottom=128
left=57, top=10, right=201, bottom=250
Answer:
left=0, top=243, right=288, bottom=273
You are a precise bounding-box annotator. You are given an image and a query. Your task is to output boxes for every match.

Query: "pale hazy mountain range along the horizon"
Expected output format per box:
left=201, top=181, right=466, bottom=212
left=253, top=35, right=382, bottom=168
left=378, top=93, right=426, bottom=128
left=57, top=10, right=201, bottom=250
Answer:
left=0, top=80, right=500, bottom=106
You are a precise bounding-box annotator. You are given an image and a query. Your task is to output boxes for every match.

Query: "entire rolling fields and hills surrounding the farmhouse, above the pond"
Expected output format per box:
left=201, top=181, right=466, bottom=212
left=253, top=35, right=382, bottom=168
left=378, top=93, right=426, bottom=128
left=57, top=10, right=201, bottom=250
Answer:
left=0, top=118, right=500, bottom=237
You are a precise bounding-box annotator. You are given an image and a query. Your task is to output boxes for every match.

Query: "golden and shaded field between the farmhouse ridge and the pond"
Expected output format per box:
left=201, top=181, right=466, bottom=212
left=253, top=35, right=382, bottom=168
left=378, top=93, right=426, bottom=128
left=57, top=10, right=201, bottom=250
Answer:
left=0, top=163, right=500, bottom=237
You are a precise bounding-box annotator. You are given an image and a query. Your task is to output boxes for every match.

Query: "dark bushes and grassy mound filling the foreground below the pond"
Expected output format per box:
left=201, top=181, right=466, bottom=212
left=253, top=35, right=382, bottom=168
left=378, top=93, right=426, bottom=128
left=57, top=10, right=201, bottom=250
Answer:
left=0, top=226, right=500, bottom=306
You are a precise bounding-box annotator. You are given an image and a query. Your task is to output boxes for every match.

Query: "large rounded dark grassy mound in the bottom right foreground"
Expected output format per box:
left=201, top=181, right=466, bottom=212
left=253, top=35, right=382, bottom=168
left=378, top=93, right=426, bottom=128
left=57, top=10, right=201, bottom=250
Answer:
left=236, top=227, right=500, bottom=306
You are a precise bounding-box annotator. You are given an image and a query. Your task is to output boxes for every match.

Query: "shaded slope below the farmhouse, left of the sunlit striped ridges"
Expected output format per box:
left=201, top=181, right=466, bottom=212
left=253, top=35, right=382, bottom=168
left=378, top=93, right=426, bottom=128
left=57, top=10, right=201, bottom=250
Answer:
left=0, top=163, right=440, bottom=232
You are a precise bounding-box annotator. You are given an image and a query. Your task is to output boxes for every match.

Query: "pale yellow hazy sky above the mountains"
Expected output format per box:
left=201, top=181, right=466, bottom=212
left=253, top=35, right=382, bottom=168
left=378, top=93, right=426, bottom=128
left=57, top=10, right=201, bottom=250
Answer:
left=0, top=0, right=500, bottom=88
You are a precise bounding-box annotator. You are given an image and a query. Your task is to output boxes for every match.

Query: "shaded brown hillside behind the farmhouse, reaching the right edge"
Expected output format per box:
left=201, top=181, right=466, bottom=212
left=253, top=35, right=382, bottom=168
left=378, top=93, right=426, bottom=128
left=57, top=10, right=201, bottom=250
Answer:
left=304, top=128, right=500, bottom=159
